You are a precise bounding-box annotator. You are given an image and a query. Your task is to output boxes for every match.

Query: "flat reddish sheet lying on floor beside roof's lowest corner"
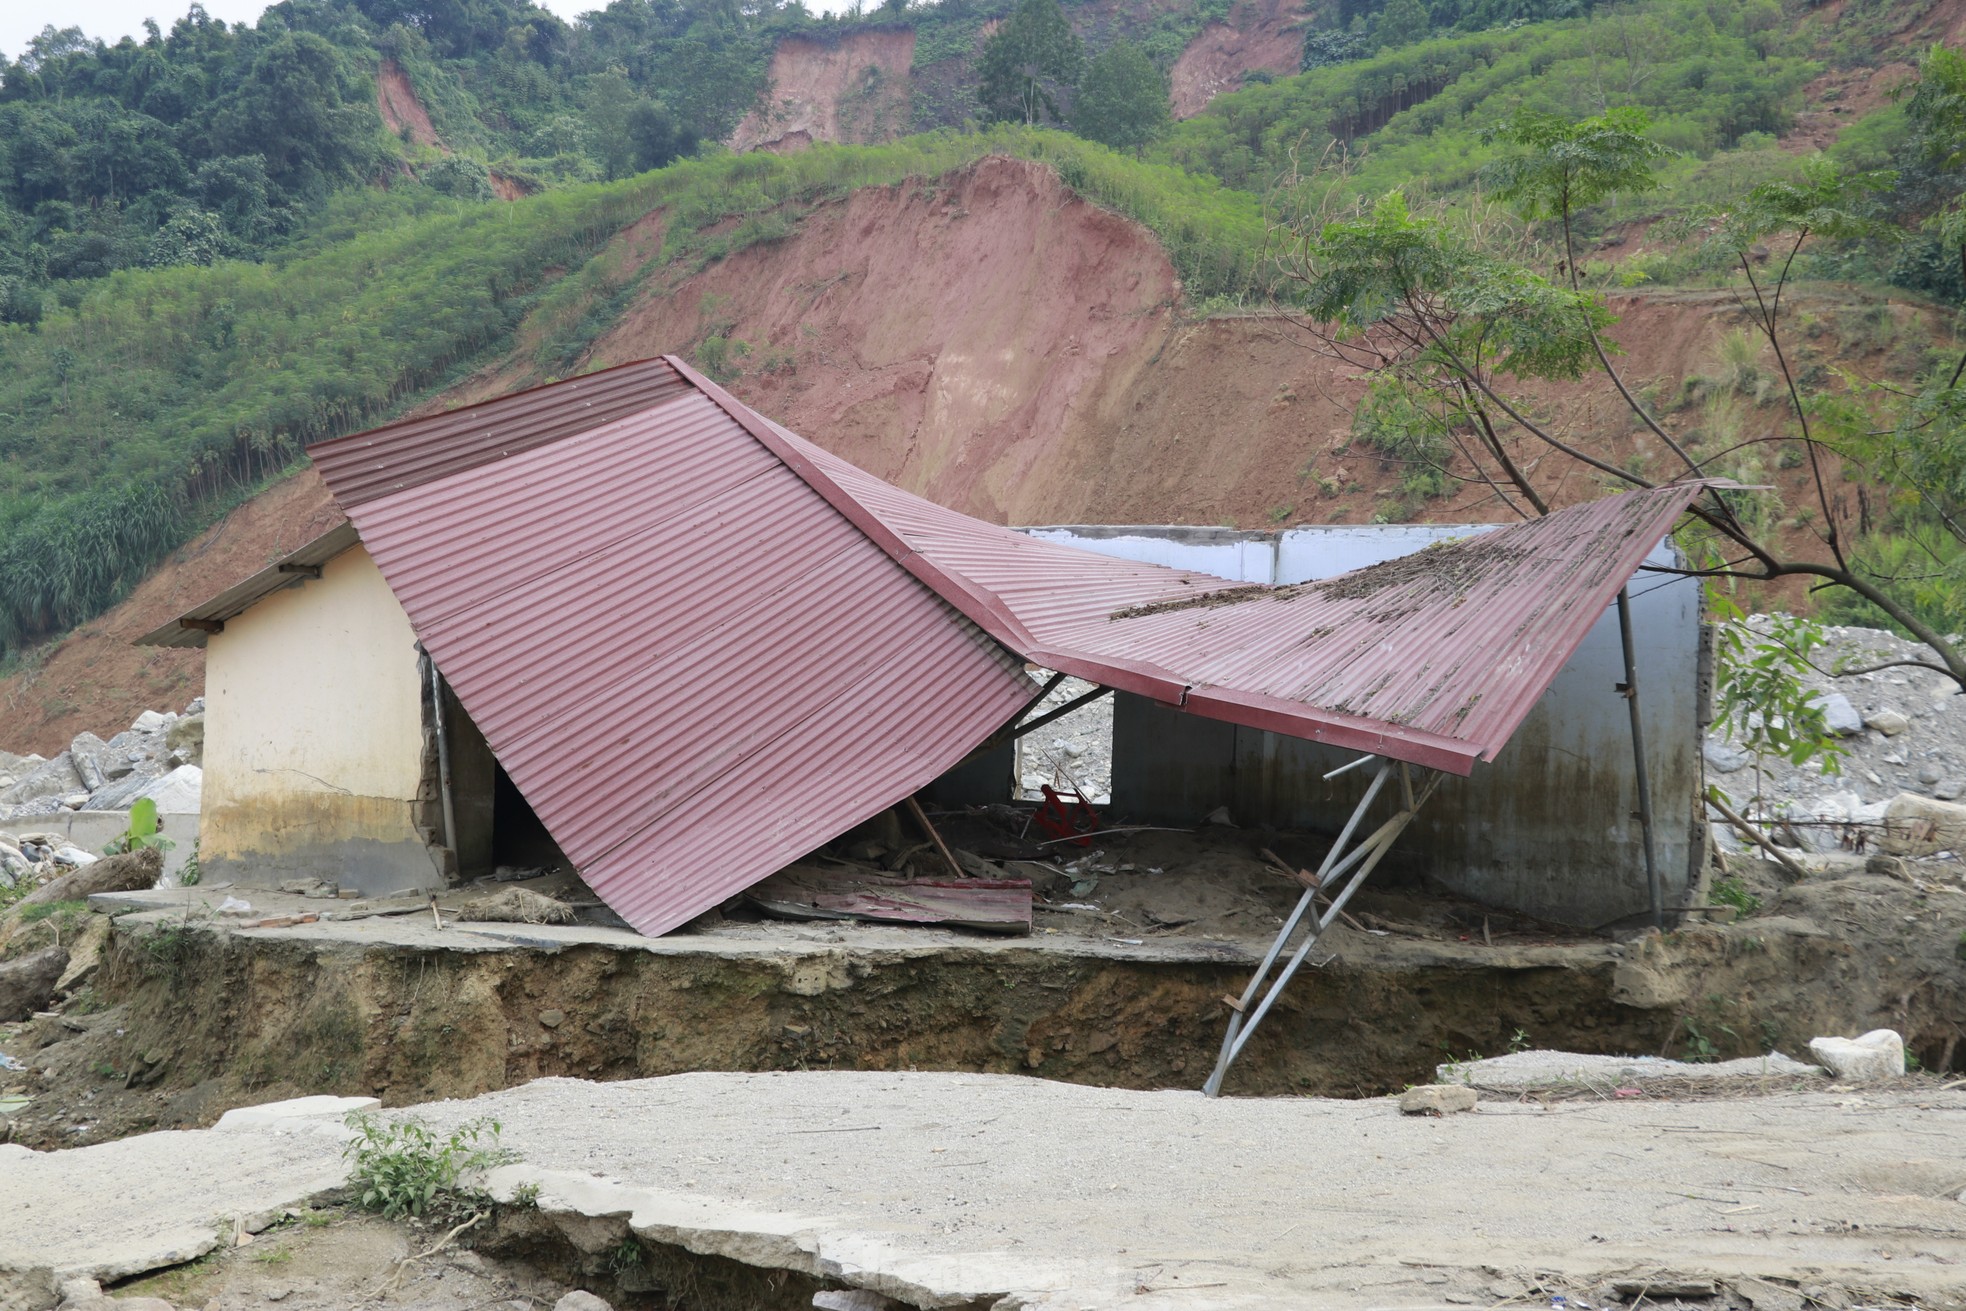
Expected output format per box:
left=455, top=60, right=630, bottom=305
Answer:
left=745, top=865, right=1030, bottom=934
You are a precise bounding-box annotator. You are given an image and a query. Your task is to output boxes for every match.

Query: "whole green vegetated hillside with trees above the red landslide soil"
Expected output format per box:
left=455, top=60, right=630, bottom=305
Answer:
left=0, top=0, right=1966, bottom=653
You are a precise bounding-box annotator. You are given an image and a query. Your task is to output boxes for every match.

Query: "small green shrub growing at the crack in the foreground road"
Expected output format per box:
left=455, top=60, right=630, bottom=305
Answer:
left=342, top=1112, right=517, bottom=1221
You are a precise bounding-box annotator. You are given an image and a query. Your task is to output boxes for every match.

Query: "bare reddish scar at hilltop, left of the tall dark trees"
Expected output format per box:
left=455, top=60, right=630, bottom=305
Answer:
left=729, top=28, right=914, bottom=149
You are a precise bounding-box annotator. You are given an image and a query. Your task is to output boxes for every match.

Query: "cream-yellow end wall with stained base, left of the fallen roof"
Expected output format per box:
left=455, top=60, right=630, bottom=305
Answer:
left=199, top=546, right=442, bottom=892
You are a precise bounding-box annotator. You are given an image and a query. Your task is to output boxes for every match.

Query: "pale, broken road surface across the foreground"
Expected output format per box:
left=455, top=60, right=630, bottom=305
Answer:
left=0, top=1071, right=1966, bottom=1309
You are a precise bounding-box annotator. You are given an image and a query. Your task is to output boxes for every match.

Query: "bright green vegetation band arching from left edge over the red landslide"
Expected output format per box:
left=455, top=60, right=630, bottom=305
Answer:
left=0, top=128, right=1264, bottom=647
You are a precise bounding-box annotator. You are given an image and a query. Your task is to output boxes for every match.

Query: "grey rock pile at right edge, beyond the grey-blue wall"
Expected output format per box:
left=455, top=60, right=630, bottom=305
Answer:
left=1705, top=615, right=1966, bottom=861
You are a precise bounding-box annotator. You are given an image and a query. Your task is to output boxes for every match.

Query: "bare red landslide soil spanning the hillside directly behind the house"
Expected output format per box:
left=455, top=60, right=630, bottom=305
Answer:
left=0, top=157, right=1938, bottom=753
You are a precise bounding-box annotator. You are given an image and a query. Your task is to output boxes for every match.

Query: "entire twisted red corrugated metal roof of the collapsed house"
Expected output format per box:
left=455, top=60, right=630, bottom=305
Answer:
left=311, top=358, right=1701, bottom=934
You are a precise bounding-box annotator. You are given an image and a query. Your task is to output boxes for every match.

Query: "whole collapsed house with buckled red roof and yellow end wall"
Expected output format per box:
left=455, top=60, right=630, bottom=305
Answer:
left=140, top=358, right=1705, bottom=1037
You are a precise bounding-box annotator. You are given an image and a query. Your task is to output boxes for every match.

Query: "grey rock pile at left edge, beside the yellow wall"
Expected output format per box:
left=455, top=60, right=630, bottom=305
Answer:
left=0, top=696, right=204, bottom=825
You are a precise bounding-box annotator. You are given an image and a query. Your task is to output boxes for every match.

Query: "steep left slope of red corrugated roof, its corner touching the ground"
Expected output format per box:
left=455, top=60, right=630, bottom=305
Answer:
left=315, top=366, right=1032, bottom=934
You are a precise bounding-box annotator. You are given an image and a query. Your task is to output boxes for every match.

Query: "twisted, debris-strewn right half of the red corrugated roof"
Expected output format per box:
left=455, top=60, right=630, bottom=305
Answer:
left=678, top=362, right=1705, bottom=774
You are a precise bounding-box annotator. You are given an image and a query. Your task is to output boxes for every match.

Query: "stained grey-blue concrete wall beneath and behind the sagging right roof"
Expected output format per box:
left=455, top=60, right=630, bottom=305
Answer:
left=1034, top=525, right=1703, bottom=928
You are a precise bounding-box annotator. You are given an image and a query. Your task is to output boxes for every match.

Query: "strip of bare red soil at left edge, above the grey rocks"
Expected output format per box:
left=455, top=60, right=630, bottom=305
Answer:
left=0, top=470, right=342, bottom=755
